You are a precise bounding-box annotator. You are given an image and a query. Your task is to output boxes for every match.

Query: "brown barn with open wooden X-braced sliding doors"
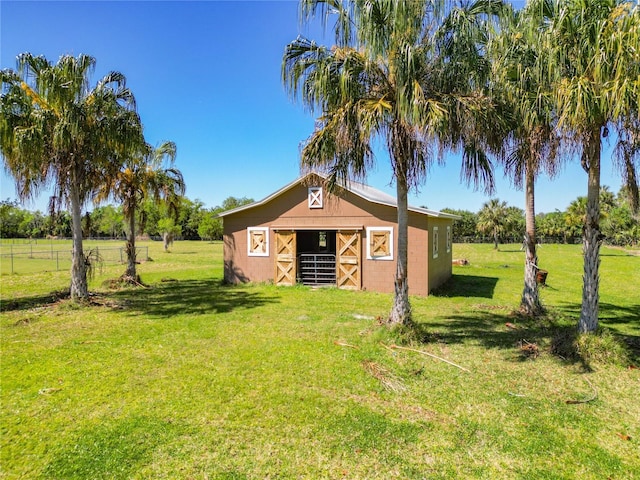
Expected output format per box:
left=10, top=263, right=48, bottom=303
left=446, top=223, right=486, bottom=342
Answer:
left=219, top=173, right=458, bottom=295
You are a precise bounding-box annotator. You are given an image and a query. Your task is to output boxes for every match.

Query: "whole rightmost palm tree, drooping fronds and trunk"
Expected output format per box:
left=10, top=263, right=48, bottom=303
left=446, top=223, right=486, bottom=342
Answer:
left=549, top=0, right=640, bottom=333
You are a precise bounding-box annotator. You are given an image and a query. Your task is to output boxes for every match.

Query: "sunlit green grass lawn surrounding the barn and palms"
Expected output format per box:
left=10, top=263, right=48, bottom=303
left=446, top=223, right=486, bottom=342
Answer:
left=0, top=242, right=640, bottom=479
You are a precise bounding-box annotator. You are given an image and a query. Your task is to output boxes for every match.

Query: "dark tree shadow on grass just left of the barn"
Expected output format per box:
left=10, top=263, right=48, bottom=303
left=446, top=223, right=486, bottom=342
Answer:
left=112, top=278, right=279, bottom=317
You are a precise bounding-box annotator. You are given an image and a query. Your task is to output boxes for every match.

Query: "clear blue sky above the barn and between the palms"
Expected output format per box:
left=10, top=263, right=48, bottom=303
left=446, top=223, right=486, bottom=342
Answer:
left=0, top=0, right=620, bottom=212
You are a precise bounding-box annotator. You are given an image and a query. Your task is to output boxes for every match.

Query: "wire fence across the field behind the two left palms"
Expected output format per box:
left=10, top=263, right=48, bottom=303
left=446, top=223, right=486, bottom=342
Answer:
left=0, top=243, right=149, bottom=275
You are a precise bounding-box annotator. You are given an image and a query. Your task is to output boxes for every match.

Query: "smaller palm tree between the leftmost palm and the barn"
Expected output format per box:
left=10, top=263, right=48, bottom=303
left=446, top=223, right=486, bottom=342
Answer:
left=96, top=142, right=185, bottom=283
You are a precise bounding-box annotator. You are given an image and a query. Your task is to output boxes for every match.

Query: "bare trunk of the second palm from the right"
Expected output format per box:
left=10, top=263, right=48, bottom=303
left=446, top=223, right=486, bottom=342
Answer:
left=520, top=165, right=542, bottom=315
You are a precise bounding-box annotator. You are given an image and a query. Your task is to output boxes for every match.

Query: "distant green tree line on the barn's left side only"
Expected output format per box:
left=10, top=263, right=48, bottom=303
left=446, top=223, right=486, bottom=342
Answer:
left=0, top=197, right=253, bottom=240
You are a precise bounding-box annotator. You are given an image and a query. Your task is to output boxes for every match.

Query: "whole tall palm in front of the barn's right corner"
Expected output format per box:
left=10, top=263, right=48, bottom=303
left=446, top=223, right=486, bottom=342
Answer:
left=282, top=0, right=500, bottom=324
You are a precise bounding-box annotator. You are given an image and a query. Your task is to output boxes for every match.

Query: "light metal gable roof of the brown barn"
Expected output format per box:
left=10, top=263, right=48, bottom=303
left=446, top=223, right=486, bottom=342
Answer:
left=217, top=172, right=461, bottom=220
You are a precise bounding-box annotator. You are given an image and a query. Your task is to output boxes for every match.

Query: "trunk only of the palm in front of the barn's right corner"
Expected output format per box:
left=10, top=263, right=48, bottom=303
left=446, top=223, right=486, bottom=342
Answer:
left=389, top=173, right=411, bottom=325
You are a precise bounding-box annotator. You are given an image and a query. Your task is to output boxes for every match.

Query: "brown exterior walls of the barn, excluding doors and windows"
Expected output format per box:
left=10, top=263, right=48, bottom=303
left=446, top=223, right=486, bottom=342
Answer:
left=224, top=185, right=451, bottom=295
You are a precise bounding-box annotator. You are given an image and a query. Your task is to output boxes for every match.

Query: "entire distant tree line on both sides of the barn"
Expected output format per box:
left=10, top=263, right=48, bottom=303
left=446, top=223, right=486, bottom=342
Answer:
left=0, top=187, right=640, bottom=246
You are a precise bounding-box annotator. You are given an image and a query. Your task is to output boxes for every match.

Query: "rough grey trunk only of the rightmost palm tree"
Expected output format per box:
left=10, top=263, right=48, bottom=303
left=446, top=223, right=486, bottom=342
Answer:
left=578, top=128, right=602, bottom=333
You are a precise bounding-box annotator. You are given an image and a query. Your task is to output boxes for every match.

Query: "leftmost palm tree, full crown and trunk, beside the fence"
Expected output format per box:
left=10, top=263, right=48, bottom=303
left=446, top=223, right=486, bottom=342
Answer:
left=0, top=53, right=142, bottom=300
